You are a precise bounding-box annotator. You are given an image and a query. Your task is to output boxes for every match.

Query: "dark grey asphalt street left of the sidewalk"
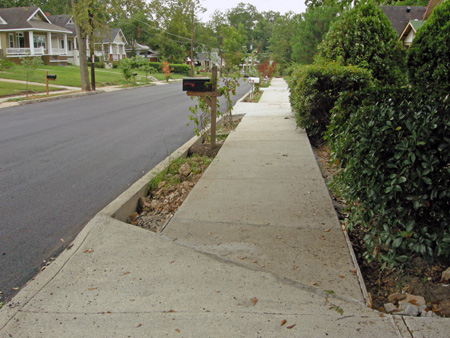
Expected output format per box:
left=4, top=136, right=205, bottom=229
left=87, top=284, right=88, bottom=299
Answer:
left=0, top=83, right=249, bottom=301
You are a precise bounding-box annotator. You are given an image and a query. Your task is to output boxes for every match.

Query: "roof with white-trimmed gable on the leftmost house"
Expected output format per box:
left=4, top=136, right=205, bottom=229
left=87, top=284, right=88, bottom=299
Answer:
left=0, top=7, right=70, bottom=33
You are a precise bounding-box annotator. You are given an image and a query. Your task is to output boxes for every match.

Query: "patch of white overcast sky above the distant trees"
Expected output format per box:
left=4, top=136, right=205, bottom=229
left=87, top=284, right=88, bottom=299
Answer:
left=201, top=0, right=306, bottom=22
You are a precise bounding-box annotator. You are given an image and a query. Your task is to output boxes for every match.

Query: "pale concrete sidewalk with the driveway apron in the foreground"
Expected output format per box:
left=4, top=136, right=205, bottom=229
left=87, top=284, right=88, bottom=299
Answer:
left=0, top=79, right=450, bottom=337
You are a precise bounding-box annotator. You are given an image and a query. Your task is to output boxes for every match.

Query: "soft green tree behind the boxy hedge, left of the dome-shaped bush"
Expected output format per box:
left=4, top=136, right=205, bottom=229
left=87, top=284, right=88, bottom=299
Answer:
left=290, top=6, right=338, bottom=64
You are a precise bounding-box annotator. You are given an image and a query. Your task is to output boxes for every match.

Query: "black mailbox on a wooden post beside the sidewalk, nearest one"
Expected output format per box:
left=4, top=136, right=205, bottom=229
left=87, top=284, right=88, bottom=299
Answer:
left=183, top=66, right=222, bottom=149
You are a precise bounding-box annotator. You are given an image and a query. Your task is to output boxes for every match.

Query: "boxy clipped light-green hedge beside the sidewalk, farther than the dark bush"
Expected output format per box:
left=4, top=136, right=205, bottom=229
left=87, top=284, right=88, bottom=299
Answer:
left=289, top=62, right=371, bottom=140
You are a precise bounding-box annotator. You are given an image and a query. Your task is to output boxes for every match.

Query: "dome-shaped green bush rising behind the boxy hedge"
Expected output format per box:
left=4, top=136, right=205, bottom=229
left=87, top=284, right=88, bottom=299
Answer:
left=318, top=1, right=406, bottom=85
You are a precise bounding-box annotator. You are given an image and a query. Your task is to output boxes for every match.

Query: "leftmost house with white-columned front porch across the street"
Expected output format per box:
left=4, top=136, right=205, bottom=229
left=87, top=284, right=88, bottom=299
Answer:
left=0, top=7, right=72, bottom=65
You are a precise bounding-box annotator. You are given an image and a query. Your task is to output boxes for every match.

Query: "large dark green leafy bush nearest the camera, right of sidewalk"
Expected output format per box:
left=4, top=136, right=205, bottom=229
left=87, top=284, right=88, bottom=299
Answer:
left=328, top=88, right=450, bottom=266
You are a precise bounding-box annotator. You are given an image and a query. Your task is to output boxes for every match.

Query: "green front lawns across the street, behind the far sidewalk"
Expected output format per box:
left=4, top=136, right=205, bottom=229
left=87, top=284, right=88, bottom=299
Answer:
left=0, top=65, right=184, bottom=87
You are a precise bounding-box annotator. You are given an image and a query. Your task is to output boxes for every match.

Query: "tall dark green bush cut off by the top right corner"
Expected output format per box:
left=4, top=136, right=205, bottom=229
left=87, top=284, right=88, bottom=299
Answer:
left=407, top=1, right=450, bottom=91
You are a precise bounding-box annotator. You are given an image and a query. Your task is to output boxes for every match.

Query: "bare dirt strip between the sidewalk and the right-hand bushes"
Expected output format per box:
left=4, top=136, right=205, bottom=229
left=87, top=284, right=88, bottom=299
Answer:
left=313, top=144, right=450, bottom=317
